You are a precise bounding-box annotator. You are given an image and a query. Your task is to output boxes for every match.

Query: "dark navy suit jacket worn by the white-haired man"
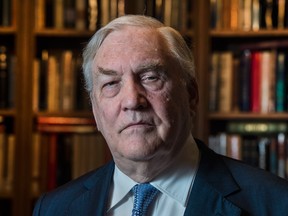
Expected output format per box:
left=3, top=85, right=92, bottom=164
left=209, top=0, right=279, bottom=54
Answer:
left=33, top=141, right=288, bottom=216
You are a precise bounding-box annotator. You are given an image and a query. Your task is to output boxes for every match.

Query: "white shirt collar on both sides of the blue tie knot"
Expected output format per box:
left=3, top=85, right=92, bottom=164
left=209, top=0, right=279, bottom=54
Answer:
left=110, top=135, right=199, bottom=208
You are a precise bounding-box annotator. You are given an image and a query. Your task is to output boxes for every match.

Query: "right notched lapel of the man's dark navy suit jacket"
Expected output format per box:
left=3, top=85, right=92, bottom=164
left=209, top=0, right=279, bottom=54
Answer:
left=185, top=141, right=241, bottom=216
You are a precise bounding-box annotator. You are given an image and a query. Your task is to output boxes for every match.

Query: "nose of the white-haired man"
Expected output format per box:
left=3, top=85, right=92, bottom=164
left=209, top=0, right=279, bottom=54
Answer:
left=122, top=80, right=148, bottom=110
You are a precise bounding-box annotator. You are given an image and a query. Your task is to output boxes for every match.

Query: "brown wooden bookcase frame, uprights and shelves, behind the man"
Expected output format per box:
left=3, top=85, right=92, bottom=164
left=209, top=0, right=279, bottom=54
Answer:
left=0, top=0, right=288, bottom=216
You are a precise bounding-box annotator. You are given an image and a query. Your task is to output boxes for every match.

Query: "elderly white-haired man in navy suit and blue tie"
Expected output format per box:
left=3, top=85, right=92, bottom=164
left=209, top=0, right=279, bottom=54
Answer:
left=34, top=15, right=288, bottom=216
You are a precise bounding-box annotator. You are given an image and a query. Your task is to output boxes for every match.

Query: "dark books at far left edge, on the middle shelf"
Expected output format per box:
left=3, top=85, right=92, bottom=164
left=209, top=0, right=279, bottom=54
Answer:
left=0, top=45, right=17, bottom=109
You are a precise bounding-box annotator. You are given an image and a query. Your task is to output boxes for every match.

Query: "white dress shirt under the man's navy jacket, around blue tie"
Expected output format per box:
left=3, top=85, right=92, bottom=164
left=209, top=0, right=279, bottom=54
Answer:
left=107, top=135, right=200, bottom=216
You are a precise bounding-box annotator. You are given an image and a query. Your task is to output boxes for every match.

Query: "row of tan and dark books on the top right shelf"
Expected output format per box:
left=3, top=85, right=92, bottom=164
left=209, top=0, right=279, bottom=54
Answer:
left=210, top=0, right=288, bottom=31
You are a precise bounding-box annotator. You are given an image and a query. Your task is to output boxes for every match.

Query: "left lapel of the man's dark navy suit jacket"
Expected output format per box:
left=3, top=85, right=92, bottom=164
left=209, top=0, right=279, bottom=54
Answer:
left=67, top=163, right=114, bottom=216
